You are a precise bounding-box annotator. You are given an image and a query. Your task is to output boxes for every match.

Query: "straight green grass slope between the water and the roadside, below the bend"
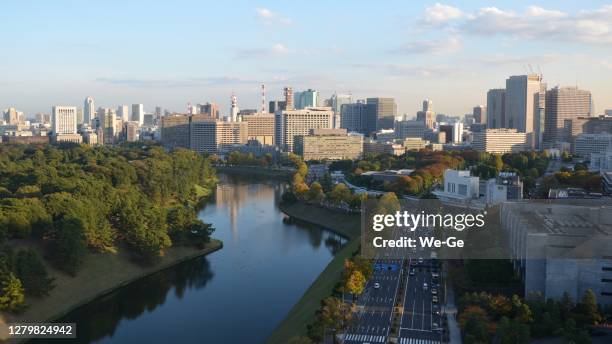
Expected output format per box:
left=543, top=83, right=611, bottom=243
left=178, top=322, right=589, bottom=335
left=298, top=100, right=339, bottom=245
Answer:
left=266, top=237, right=361, bottom=344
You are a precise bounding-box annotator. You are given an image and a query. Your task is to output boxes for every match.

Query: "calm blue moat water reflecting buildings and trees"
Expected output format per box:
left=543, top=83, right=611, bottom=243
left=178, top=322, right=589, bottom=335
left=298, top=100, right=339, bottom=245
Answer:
left=52, top=175, right=345, bottom=343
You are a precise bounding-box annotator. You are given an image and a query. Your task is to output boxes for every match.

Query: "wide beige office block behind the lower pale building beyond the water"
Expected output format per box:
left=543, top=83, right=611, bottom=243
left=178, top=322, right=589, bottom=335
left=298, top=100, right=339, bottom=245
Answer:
left=274, top=108, right=334, bottom=152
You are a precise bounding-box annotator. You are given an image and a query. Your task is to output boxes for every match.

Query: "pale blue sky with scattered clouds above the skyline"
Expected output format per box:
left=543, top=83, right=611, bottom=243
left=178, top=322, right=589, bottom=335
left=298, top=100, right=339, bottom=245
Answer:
left=0, top=0, right=612, bottom=115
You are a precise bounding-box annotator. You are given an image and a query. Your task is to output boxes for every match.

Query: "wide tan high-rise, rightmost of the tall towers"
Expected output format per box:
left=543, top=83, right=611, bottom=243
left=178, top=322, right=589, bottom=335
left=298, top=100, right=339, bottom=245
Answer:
left=544, top=87, right=591, bottom=143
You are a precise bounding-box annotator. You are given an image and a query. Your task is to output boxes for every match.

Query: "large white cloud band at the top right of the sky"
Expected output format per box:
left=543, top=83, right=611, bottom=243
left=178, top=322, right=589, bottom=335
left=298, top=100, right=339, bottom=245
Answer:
left=459, top=5, right=612, bottom=44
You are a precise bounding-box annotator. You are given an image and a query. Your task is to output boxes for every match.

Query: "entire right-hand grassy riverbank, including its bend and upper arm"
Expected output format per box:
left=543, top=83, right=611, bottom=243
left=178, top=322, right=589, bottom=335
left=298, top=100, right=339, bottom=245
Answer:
left=266, top=202, right=361, bottom=344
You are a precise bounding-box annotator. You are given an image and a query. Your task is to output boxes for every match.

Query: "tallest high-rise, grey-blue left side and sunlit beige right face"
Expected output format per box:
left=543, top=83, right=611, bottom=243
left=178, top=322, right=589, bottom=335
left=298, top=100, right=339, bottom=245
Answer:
left=504, top=74, right=545, bottom=148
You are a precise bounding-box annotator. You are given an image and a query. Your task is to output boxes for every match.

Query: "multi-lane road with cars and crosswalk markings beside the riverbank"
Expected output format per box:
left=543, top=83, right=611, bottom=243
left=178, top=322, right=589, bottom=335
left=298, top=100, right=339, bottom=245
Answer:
left=343, top=259, right=444, bottom=344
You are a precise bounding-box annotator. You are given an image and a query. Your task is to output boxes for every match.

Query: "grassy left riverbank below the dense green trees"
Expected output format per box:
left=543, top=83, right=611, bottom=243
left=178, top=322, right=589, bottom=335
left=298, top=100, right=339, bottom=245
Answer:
left=0, top=239, right=223, bottom=340
